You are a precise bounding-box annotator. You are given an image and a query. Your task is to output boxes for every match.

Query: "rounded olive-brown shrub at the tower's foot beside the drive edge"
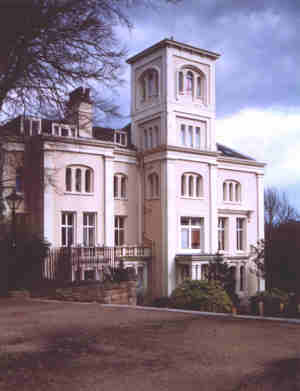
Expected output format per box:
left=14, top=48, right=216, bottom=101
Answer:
left=171, top=280, right=233, bottom=312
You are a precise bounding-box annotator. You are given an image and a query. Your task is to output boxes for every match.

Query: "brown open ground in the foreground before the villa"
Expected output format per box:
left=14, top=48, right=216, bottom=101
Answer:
left=0, top=299, right=300, bottom=391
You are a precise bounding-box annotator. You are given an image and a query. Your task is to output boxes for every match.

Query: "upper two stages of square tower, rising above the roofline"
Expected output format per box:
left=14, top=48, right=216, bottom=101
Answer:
left=127, top=39, right=219, bottom=152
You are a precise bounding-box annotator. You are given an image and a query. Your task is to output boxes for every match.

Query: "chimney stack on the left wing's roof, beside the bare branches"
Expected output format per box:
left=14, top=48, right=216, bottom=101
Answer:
left=67, top=87, right=93, bottom=138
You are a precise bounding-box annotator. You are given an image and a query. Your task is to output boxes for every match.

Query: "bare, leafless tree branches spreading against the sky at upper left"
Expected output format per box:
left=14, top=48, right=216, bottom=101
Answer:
left=0, top=0, right=178, bottom=123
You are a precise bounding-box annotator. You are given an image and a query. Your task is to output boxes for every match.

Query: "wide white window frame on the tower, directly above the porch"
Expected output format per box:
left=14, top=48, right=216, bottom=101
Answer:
left=179, top=216, right=205, bottom=253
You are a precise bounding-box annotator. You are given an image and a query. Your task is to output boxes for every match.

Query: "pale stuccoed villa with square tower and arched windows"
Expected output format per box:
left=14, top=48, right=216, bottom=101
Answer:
left=2, top=39, right=264, bottom=297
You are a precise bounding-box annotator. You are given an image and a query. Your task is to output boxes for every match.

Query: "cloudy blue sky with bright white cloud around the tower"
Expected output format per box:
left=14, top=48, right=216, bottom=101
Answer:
left=109, top=0, right=300, bottom=210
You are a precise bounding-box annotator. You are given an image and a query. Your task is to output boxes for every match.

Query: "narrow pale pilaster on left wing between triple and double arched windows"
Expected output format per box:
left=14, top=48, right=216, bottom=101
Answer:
left=104, top=156, right=114, bottom=247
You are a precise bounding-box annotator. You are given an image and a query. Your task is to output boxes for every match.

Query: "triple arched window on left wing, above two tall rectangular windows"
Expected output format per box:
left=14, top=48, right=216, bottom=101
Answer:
left=65, top=165, right=94, bottom=193
